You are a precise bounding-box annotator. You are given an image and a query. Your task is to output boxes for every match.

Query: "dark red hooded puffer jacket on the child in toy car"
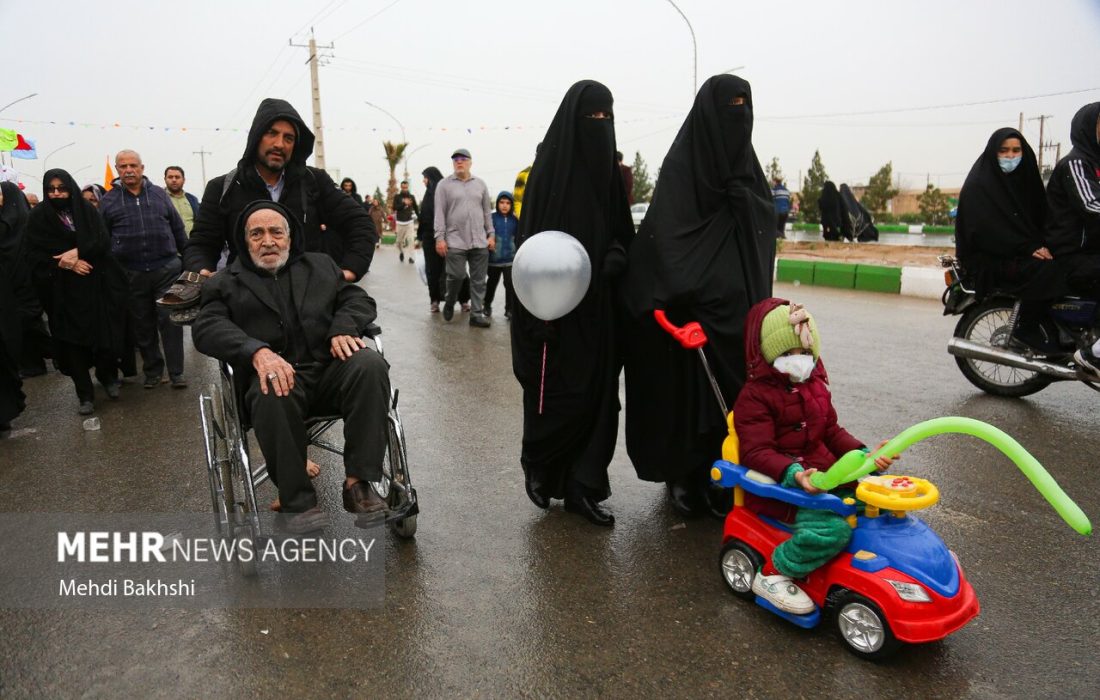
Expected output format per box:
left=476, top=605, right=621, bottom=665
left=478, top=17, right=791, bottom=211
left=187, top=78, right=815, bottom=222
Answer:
left=734, top=298, right=864, bottom=521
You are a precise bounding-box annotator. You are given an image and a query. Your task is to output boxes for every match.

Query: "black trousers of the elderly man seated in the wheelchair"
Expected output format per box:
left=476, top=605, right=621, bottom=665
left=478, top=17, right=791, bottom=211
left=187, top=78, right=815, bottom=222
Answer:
left=244, top=349, right=389, bottom=513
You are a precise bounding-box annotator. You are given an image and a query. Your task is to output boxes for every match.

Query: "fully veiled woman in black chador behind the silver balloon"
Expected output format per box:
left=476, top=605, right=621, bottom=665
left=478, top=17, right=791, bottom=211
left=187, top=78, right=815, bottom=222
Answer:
left=512, top=80, right=634, bottom=525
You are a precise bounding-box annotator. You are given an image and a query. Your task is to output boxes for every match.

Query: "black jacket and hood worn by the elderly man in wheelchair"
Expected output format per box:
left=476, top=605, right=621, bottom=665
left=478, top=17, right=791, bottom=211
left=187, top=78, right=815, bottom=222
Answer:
left=191, top=199, right=376, bottom=376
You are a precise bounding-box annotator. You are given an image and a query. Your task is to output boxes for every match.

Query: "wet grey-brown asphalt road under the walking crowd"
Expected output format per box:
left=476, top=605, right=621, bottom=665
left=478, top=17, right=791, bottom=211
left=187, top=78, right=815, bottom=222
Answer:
left=0, top=249, right=1100, bottom=698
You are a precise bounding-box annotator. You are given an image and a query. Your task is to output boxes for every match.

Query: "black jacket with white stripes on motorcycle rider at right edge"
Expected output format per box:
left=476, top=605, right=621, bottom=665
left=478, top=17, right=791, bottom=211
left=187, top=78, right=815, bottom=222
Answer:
left=1046, top=102, right=1100, bottom=259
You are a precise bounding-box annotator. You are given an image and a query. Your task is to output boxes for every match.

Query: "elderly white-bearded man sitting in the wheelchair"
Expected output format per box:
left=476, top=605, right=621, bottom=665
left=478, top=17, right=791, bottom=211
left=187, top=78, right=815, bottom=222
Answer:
left=191, top=201, right=391, bottom=533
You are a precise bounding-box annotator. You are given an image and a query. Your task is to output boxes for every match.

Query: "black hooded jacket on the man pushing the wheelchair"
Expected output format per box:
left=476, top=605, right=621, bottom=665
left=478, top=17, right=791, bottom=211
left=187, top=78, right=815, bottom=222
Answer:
left=184, top=98, right=378, bottom=280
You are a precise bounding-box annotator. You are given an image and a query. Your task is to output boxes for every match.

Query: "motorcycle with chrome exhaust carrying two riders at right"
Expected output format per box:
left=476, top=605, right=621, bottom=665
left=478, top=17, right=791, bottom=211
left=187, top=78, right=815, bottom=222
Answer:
left=939, top=255, right=1100, bottom=397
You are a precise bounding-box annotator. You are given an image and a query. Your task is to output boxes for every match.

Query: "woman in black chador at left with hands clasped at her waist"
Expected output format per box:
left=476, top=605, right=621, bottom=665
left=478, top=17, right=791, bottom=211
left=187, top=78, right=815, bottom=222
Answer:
left=26, top=169, right=127, bottom=414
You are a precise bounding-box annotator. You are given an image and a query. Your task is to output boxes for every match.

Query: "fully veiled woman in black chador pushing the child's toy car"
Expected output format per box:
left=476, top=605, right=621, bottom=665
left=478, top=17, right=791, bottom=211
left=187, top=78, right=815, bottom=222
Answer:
left=624, top=75, right=776, bottom=514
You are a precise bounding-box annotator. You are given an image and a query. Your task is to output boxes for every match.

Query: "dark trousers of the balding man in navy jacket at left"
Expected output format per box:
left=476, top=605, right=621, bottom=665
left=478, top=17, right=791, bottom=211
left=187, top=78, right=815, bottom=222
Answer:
left=127, top=260, right=184, bottom=379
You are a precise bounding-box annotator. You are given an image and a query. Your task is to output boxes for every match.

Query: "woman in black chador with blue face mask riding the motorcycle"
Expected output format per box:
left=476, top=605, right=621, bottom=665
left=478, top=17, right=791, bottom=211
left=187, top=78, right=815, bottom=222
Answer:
left=955, top=129, right=1066, bottom=352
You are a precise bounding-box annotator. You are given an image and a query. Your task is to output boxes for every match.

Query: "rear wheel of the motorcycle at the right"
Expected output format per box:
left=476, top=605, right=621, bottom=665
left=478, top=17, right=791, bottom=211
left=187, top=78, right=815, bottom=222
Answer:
left=955, top=299, right=1053, bottom=398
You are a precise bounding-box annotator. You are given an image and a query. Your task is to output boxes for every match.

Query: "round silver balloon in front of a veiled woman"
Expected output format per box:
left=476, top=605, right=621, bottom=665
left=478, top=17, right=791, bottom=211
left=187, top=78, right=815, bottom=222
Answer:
left=512, top=231, right=592, bottom=320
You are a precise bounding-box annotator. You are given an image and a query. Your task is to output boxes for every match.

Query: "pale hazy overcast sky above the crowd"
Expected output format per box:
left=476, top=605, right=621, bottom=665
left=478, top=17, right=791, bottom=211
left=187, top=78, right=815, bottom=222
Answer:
left=0, top=0, right=1100, bottom=193
